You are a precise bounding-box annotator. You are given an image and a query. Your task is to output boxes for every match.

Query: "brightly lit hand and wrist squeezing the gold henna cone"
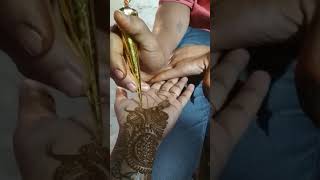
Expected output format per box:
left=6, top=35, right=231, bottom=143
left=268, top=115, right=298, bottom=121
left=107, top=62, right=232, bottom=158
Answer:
left=110, top=3, right=190, bottom=91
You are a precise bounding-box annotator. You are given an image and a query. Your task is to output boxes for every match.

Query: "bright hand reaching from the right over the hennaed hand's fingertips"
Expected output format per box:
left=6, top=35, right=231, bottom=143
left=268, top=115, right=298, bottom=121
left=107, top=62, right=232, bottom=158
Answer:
left=150, top=45, right=210, bottom=83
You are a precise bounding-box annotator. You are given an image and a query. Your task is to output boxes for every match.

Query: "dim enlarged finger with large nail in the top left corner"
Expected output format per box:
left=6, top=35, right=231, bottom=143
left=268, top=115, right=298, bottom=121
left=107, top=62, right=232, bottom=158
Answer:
left=0, top=0, right=54, bottom=57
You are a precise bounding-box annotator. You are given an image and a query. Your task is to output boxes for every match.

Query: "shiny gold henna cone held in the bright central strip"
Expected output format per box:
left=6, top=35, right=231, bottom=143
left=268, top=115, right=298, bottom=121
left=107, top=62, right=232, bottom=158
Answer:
left=120, top=4, right=142, bottom=107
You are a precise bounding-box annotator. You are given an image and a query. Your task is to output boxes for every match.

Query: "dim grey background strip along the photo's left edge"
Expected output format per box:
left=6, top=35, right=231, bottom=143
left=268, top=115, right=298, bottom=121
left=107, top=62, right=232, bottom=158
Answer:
left=0, top=51, right=21, bottom=180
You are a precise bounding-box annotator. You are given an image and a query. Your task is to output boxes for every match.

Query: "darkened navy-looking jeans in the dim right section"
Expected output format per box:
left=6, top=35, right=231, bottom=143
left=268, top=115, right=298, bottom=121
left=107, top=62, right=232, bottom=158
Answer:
left=221, top=64, right=320, bottom=180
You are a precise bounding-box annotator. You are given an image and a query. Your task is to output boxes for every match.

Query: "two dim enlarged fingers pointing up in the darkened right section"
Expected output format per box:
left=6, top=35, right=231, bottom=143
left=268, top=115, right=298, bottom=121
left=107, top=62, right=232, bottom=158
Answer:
left=210, top=50, right=270, bottom=180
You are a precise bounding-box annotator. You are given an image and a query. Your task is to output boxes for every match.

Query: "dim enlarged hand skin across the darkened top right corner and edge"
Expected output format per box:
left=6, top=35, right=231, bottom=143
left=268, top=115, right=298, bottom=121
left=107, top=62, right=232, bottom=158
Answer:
left=213, top=0, right=320, bottom=127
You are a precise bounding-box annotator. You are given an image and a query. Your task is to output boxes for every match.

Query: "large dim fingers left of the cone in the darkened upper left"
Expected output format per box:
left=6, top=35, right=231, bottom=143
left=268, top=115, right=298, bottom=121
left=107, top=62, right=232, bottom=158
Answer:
left=0, top=0, right=108, bottom=96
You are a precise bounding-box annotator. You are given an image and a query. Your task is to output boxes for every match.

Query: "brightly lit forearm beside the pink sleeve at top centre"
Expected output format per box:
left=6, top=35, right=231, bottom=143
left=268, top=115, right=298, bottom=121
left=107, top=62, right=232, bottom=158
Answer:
left=153, top=2, right=190, bottom=60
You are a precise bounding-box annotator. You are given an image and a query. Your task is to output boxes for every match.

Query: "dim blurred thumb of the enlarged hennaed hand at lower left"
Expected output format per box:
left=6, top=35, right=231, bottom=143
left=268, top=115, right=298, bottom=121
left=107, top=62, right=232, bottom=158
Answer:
left=17, top=80, right=56, bottom=129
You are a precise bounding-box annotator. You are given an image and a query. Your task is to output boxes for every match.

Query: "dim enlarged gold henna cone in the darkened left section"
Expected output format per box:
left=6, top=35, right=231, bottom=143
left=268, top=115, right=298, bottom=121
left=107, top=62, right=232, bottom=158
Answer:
left=58, top=0, right=103, bottom=144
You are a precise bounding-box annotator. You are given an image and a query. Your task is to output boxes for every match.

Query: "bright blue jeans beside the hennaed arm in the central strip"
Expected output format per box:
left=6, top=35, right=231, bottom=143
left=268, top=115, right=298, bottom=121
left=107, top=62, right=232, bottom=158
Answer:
left=152, top=28, right=211, bottom=180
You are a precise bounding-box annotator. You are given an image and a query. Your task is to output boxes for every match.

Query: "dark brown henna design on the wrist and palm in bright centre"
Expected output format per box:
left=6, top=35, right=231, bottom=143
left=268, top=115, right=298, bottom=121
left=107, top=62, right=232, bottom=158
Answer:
left=111, top=100, right=170, bottom=179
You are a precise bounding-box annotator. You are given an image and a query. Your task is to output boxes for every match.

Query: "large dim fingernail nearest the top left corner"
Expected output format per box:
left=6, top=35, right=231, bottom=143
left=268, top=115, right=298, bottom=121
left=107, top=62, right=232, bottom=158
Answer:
left=17, top=24, right=43, bottom=56
